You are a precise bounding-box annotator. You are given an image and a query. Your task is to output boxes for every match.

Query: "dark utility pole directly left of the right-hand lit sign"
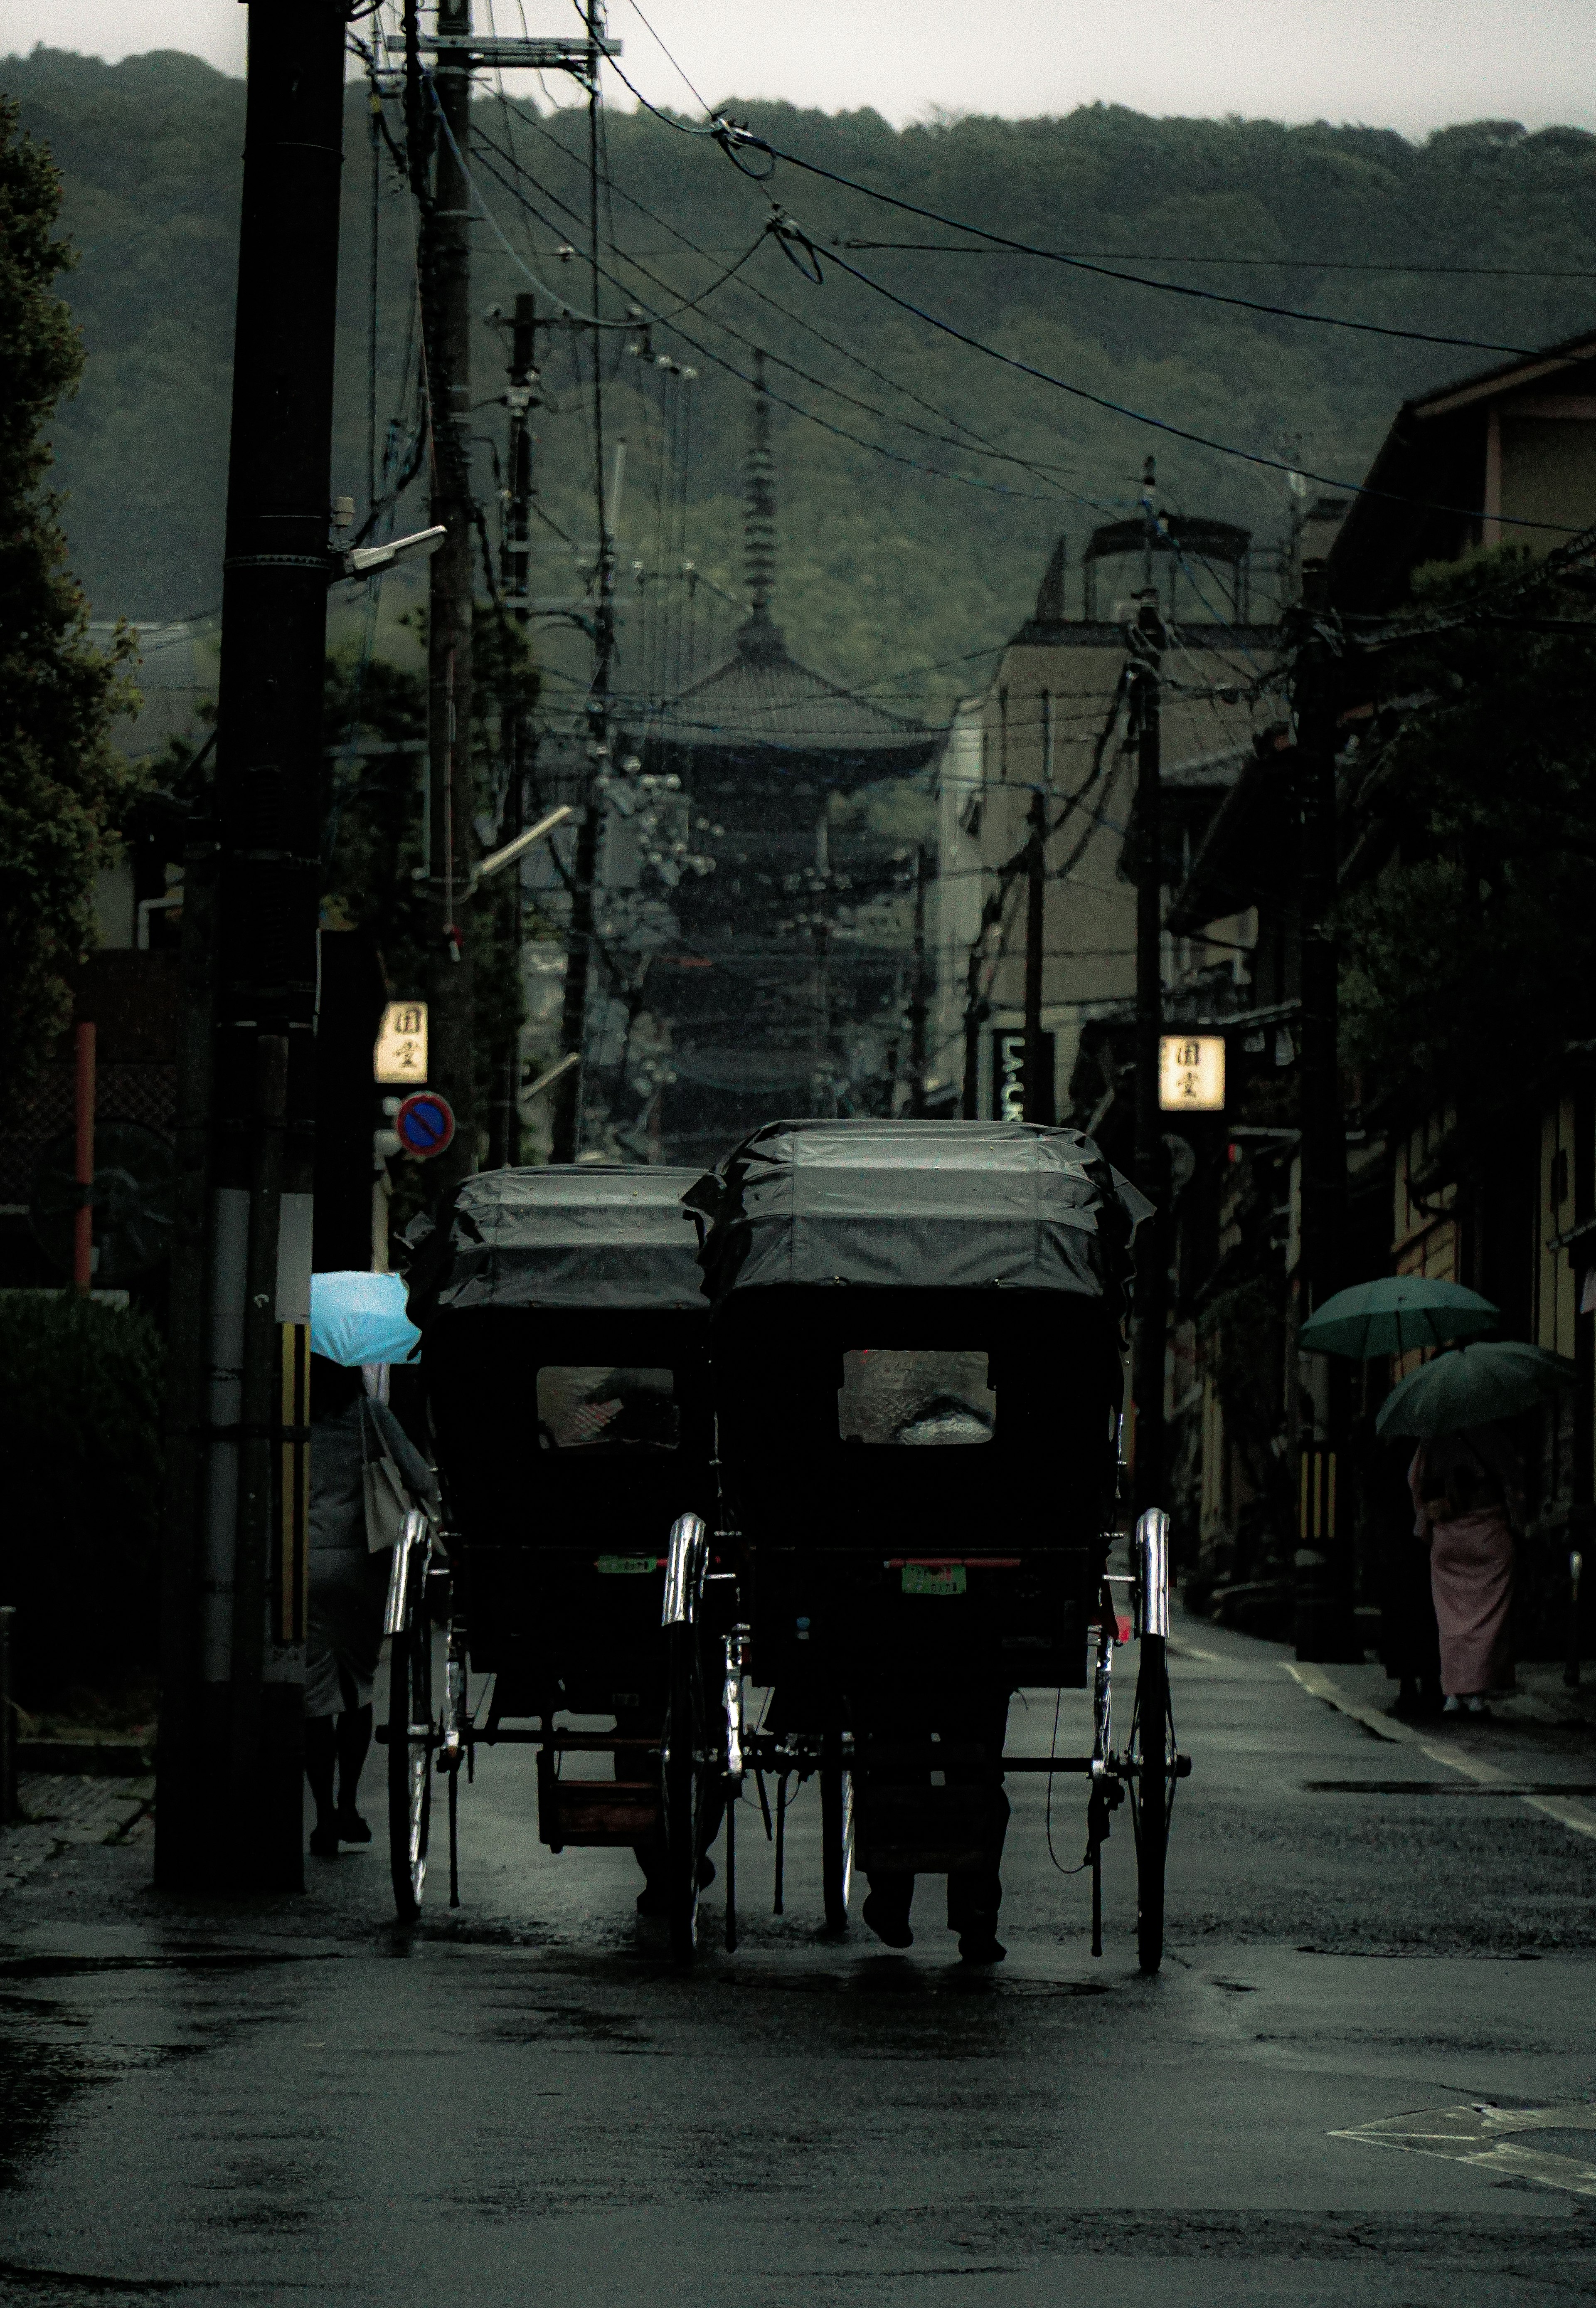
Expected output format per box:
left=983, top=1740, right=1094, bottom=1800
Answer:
left=1133, top=595, right=1169, bottom=1512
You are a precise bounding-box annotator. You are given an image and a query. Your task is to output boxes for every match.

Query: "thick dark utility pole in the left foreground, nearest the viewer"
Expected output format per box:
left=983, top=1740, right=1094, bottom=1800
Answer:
left=157, top=0, right=348, bottom=1890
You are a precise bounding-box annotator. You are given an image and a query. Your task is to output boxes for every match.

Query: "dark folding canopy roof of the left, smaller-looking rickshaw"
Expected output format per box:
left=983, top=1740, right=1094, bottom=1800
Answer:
left=408, top=1163, right=708, bottom=1329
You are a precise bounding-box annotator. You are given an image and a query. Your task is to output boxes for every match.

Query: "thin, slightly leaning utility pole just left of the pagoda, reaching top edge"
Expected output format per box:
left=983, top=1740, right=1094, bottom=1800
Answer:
left=549, top=0, right=616, bottom=1161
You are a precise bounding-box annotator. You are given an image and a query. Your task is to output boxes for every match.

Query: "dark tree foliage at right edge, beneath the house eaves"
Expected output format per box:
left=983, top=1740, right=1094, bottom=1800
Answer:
left=1342, top=547, right=1596, bottom=1135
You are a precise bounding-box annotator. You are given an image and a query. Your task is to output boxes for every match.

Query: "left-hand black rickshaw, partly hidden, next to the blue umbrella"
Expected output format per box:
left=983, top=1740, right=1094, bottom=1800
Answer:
left=387, top=1163, right=731, bottom=1953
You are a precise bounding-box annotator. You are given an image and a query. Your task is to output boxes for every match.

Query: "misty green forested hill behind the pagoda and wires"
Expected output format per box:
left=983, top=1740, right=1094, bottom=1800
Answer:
left=0, top=49, right=1596, bottom=706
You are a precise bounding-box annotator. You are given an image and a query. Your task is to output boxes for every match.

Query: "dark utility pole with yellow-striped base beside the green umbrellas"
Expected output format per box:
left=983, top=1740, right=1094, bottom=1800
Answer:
left=1292, top=561, right=1363, bottom=1659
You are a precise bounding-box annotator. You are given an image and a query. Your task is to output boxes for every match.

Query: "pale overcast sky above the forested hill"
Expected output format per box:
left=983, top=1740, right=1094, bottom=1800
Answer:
left=0, top=0, right=1596, bottom=136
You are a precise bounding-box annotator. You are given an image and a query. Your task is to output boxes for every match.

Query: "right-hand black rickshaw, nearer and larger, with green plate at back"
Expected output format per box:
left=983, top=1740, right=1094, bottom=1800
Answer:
left=692, top=1122, right=1188, bottom=1971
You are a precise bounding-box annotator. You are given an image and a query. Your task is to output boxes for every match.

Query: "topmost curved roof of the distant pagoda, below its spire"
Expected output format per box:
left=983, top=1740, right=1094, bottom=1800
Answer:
left=650, top=609, right=938, bottom=775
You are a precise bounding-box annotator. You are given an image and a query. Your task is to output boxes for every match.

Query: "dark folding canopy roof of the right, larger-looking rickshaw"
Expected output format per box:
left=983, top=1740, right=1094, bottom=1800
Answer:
left=692, top=1122, right=1151, bottom=1316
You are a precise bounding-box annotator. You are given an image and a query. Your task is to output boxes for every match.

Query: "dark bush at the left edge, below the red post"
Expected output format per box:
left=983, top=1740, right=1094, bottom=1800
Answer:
left=0, top=1290, right=164, bottom=1708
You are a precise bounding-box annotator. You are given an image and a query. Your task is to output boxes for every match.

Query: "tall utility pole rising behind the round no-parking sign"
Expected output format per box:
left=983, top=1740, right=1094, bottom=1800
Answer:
left=415, top=0, right=478, bottom=1193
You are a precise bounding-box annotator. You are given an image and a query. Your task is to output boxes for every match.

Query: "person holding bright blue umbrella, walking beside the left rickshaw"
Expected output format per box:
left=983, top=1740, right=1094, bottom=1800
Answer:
left=304, top=1274, right=438, bottom=1860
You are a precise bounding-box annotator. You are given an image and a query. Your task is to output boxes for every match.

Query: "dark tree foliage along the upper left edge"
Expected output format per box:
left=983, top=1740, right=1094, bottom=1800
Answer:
left=0, top=97, right=136, bottom=1073
